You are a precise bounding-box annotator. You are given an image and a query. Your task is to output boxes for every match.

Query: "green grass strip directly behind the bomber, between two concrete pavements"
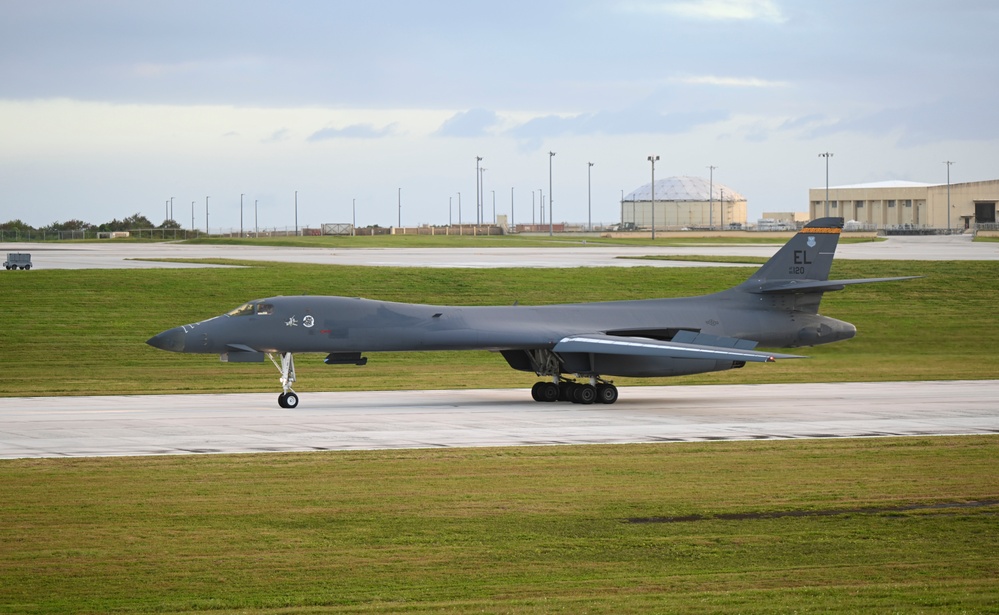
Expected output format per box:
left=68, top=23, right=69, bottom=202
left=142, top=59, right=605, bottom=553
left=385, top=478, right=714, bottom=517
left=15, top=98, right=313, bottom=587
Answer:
left=0, top=261, right=999, bottom=396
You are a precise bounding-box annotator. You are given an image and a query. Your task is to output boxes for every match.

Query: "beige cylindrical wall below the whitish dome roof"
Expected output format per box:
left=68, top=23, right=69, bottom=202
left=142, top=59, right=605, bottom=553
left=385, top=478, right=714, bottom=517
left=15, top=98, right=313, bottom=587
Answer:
left=621, top=199, right=746, bottom=229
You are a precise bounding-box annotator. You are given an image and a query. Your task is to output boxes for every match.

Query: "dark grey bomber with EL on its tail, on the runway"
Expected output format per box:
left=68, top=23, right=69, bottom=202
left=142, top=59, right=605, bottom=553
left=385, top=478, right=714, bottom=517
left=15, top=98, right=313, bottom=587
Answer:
left=147, top=218, right=910, bottom=408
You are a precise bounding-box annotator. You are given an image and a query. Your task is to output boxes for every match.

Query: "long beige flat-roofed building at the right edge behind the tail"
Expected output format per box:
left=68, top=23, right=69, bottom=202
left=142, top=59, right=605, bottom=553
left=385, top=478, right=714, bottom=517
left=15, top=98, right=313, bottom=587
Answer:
left=808, top=179, right=999, bottom=231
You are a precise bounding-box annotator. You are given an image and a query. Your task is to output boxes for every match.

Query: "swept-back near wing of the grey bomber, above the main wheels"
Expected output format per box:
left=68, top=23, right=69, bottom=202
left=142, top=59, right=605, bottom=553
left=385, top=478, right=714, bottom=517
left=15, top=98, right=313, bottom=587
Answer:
left=553, top=334, right=804, bottom=363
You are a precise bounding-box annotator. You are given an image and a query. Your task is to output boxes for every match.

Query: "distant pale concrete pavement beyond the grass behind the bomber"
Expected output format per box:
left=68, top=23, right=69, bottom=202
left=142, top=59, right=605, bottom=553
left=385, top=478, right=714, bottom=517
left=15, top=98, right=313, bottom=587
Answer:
left=0, top=235, right=999, bottom=269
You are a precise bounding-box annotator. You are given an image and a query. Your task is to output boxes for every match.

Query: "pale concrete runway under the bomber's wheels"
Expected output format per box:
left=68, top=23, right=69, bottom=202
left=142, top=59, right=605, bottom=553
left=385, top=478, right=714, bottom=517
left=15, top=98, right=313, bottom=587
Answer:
left=0, top=380, right=999, bottom=458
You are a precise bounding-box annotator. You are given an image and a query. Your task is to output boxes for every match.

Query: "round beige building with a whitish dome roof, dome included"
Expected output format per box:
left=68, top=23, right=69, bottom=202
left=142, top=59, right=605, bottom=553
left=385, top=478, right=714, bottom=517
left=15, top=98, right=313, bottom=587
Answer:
left=621, top=176, right=746, bottom=230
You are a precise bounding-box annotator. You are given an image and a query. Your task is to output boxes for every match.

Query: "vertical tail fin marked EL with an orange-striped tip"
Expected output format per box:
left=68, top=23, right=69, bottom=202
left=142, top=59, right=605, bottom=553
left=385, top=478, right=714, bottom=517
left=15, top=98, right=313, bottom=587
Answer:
left=739, top=218, right=843, bottom=292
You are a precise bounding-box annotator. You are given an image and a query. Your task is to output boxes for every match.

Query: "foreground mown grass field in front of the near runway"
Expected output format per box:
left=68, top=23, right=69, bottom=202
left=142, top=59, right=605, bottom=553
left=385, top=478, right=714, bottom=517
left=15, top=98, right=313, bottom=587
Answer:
left=0, top=436, right=999, bottom=613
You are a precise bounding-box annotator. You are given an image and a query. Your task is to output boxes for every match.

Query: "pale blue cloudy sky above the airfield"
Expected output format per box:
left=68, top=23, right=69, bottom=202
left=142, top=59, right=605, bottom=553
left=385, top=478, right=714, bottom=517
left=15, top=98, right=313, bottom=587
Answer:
left=0, top=0, right=999, bottom=229
